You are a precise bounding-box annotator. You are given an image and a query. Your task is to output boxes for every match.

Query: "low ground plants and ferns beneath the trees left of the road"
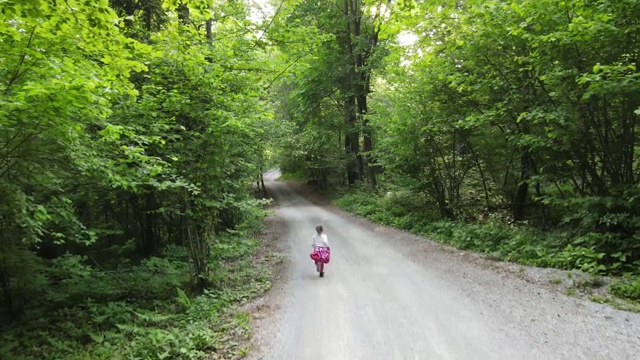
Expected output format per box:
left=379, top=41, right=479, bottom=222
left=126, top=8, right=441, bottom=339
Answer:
left=0, top=233, right=270, bottom=360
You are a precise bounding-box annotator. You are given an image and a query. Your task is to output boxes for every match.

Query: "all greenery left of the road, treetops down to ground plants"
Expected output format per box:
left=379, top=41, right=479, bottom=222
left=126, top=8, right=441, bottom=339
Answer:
left=0, top=0, right=273, bottom=359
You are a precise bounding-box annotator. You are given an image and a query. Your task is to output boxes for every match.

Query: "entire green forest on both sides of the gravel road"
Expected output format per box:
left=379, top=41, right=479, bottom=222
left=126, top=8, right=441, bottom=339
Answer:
left=0, top=0, right=640, bottom=359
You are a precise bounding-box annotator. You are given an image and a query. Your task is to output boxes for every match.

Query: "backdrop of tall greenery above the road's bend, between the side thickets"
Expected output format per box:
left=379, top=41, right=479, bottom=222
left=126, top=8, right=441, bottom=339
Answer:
left=267, top=0, right=395, bottom=188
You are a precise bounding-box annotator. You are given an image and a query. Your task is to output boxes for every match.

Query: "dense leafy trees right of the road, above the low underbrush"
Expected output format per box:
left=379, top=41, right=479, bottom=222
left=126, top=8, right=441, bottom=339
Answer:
left=371, top=1, right=640, bottom=261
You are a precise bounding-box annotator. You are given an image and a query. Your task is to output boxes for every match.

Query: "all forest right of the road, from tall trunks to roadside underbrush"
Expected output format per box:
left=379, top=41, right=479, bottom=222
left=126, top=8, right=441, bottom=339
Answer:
left=272, top=0, right=640, bottom=309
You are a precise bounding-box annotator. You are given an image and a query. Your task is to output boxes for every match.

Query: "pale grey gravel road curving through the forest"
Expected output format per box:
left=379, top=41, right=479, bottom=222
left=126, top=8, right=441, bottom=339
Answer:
left=250, top=172, right=640, bottom=360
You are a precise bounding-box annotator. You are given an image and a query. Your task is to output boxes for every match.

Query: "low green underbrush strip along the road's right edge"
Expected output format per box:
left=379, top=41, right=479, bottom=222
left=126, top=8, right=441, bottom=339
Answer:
left=333, top=188, right=640, bottom=302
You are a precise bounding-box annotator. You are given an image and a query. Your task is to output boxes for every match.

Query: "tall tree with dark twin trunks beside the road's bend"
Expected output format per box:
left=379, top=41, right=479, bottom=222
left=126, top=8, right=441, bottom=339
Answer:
left=269, top=0, right=391, bottom=190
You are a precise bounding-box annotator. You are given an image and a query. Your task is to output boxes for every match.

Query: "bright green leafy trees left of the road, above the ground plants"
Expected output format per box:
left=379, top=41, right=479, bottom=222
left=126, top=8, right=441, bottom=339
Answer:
left=0, top=0, right=270, bottom=317
